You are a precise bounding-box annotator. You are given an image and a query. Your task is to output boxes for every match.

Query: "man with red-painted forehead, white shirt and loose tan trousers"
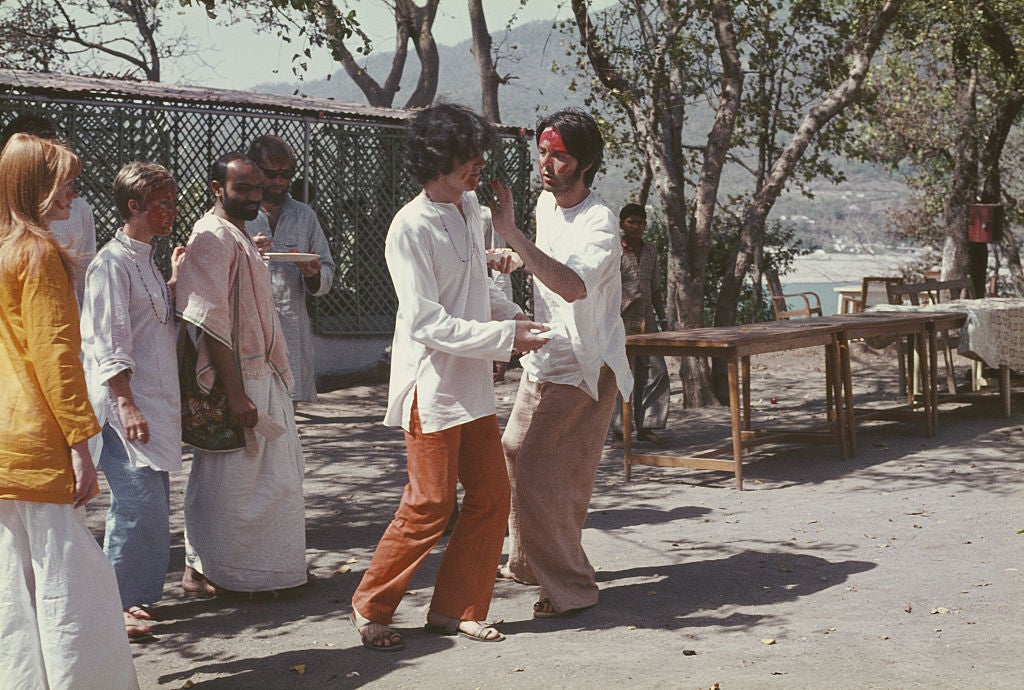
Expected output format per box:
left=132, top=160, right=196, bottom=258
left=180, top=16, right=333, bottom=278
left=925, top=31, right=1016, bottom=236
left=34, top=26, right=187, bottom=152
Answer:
left=492, top=109, right=633, bottom=618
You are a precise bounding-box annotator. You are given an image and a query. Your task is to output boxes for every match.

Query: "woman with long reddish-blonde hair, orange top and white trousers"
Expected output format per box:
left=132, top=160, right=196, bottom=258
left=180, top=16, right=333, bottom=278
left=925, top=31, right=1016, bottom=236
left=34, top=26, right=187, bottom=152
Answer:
left=0, top=134, right=138, bottom=688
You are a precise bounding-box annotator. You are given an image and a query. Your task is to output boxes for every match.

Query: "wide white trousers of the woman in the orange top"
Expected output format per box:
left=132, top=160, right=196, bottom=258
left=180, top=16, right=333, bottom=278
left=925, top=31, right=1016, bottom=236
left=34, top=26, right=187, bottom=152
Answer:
left=0, top=500, right=138, bottom=690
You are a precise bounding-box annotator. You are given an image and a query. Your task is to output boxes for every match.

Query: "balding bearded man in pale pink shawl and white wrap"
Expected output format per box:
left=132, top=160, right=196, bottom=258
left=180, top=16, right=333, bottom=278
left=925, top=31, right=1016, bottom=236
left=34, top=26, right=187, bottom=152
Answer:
left=176, top=154, right=306, bottom=594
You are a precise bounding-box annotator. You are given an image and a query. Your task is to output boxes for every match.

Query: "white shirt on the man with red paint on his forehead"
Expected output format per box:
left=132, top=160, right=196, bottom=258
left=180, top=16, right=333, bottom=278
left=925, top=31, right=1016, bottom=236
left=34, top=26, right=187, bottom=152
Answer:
left=521, top=191, right=633, bottom=400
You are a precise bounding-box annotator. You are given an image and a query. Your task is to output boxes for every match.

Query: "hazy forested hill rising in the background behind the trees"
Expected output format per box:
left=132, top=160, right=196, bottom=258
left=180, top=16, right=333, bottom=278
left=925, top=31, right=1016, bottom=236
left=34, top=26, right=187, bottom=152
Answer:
left=254, top=16, right=907, bottom=251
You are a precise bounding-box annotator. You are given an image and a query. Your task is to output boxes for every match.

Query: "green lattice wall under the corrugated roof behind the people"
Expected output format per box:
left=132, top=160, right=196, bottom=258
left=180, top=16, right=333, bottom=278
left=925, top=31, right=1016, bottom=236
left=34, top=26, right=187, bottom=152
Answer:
left=0, top=96, right=532, bottom=336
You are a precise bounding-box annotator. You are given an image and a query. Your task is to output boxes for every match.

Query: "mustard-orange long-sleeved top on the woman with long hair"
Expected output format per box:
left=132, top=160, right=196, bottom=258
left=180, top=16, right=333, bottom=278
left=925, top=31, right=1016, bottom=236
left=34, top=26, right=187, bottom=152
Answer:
left=0, top=247, right=99, bottom=504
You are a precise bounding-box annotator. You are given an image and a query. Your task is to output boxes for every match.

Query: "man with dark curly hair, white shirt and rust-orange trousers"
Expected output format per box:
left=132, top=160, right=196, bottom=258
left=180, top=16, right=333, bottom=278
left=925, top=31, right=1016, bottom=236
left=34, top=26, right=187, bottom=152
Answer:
left=351, top=104, right=547, bottom=651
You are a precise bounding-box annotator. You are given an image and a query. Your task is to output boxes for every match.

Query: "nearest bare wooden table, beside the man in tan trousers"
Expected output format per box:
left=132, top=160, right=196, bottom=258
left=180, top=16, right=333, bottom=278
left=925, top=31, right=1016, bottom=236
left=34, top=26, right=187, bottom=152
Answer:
left=623, top=318, right=850, bottom=489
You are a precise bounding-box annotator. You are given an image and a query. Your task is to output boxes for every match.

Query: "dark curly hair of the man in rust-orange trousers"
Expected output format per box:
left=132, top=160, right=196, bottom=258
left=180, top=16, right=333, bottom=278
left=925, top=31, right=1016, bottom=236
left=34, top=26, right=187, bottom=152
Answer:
left=406, top=103, right=498, bottom=185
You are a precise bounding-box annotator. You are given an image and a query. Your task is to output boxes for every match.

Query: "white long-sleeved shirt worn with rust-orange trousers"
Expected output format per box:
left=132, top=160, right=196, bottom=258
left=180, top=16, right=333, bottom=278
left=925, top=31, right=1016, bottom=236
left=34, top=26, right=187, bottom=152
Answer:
left=384, top=191, right=524, bottom=433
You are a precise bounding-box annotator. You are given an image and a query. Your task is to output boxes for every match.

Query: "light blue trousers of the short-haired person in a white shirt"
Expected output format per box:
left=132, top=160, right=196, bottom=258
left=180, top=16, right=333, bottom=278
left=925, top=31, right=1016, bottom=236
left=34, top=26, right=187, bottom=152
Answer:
left=99, top=424, right=171, bottom=609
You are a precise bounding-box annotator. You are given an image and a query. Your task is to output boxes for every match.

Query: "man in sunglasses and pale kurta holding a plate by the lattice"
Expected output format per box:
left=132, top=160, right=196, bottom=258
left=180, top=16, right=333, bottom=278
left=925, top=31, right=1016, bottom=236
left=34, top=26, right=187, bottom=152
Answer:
left=246, top=134, right=334, bottom=402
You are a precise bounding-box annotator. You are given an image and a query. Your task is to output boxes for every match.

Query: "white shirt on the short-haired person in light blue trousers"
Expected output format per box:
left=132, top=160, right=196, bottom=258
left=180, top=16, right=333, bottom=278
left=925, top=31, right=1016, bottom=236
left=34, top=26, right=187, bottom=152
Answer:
left=81, top=230, right=181, bottom=472
